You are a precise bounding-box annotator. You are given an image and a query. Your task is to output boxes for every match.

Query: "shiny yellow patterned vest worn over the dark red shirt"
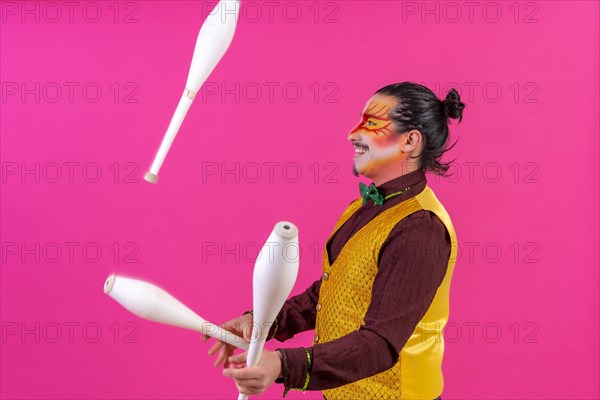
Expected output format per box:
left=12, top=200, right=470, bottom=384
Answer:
left=313, top=186, right=457, bottom=400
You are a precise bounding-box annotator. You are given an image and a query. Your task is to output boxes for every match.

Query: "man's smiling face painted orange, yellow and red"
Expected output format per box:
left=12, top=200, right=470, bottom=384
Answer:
left=348, top=94, right=408, bottom=180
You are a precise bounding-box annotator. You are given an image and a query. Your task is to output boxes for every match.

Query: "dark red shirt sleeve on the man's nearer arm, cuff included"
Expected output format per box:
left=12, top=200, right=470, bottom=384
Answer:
left=276, top=210, right=450, bottom=393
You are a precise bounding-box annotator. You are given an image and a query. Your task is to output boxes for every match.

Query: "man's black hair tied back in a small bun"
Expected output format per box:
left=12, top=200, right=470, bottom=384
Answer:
left=375, top=82, right=465, bottom=176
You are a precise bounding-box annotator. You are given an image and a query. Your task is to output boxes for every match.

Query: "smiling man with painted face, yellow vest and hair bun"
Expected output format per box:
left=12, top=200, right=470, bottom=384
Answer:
left=209, top=82, right=464, bottom=400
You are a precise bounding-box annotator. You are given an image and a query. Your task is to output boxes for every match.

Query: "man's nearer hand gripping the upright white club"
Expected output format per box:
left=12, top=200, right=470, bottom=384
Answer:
left=223, top=350, right=282, bottom=395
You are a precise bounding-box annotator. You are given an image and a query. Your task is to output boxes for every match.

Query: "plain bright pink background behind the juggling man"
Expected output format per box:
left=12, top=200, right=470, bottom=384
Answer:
left=0, top=1, right=600, bottom=399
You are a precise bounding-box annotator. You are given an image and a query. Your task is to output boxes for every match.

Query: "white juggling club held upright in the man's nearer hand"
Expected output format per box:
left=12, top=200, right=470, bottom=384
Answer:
left=238, top=221, right=300, bottom=400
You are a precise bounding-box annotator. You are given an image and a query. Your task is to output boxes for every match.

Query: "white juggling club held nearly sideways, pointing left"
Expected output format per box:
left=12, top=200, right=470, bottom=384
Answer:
left=104, top=275, right=248, bottom=349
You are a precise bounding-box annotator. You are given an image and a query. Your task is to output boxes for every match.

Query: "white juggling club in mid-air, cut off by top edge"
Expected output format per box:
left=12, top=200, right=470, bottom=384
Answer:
left=144, top=0, right=240, bottom=183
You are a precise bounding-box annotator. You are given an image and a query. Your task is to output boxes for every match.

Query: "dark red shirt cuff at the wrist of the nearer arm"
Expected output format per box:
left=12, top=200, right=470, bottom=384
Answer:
left=275, top=347, right=313, bottom=397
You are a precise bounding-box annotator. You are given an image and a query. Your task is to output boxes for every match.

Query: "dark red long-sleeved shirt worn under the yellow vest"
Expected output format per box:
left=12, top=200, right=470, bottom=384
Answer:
left=275, top=168, right=451, bottom=395
